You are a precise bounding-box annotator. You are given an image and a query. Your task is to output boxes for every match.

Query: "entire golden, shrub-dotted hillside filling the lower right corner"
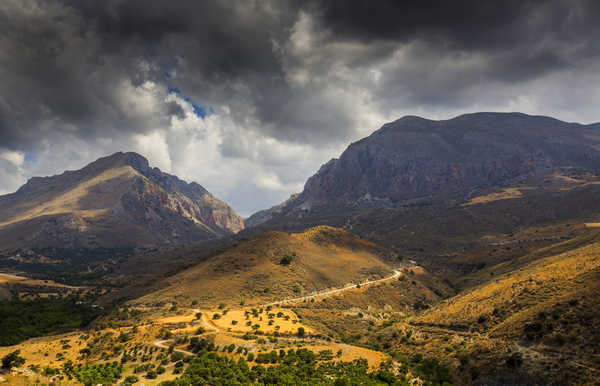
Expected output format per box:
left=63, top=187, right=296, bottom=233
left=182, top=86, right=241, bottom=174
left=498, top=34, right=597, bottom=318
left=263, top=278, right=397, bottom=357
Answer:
left=399, top=230, right=600, bottom=384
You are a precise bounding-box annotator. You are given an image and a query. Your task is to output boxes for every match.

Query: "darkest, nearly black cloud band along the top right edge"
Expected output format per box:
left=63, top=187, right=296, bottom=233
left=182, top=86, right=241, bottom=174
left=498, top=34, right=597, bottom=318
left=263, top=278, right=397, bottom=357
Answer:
left=310, top=0, right=600, bottom=56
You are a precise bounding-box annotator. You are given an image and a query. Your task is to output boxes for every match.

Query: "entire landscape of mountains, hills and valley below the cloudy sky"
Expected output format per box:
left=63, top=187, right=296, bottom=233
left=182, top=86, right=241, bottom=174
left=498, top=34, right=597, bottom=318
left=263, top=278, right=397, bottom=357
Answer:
left=0, top=113, right=600, bottom=386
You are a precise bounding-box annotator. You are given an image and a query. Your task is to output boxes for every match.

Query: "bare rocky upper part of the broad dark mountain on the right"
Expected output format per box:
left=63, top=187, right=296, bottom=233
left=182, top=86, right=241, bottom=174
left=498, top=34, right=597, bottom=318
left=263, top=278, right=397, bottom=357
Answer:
left=248, top=113, right=600, bottom=225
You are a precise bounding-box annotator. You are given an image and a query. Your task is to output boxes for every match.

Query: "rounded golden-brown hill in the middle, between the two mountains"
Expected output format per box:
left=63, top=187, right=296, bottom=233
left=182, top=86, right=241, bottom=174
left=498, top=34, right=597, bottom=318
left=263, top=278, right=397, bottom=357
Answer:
left=139, top=226, right=408, bottom=305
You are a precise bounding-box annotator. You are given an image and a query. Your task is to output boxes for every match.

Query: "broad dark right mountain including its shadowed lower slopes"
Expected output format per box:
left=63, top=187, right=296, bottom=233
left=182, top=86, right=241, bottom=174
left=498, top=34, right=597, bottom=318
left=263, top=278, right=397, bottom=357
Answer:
left=242, top=113, right=600, bottom=282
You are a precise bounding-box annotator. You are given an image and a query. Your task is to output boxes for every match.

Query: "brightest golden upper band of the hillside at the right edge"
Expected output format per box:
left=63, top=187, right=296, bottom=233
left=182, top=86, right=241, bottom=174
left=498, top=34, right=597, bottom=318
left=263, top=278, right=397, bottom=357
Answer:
left=417, top=232, right=600, bottom=331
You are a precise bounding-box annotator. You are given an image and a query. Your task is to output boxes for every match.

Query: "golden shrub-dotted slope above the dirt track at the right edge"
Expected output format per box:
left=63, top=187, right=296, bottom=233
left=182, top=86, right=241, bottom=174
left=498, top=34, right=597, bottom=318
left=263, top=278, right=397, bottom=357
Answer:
left=415, top=232, right=600, bottom=346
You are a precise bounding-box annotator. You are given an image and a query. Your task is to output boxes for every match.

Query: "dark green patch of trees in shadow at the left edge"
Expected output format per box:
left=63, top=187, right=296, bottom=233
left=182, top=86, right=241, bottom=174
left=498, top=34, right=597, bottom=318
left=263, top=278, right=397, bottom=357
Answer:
left=0, top=298, right=98, bottom=346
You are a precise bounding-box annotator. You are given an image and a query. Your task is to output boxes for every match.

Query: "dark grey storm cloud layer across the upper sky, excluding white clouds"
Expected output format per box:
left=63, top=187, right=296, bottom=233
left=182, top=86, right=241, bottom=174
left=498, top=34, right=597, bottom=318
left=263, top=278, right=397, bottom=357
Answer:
left=0, top=0, right=600, bottom=151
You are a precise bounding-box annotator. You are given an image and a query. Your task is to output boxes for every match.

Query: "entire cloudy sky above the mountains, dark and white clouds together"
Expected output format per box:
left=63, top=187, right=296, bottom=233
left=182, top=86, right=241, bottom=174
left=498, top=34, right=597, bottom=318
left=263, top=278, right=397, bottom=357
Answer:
left=0, top=0, right=600, bottom=216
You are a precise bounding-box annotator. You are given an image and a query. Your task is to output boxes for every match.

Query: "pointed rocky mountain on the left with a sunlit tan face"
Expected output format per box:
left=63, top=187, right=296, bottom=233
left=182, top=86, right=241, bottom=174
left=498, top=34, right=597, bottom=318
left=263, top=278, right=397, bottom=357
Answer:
left=0, top=152, right=244, bottom=250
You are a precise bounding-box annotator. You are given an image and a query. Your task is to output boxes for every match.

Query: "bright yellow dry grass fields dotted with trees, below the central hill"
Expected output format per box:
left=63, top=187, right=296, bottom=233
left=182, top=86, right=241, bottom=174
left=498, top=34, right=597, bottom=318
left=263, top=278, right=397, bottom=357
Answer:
left=0, top=298, right=389, bottom=385
